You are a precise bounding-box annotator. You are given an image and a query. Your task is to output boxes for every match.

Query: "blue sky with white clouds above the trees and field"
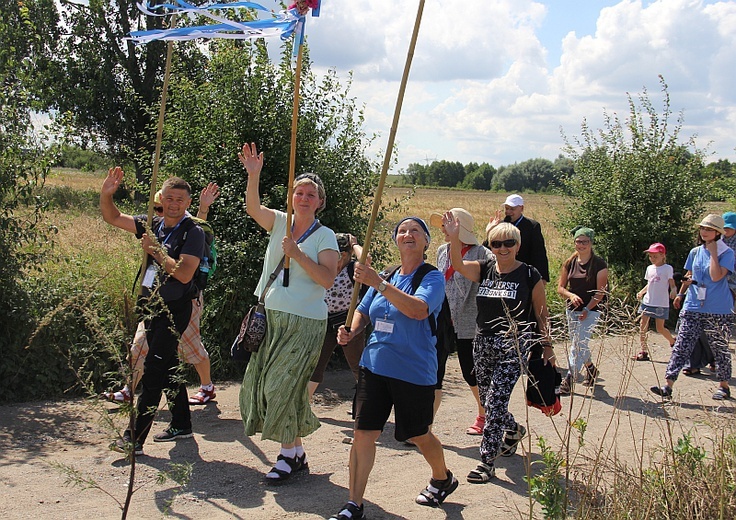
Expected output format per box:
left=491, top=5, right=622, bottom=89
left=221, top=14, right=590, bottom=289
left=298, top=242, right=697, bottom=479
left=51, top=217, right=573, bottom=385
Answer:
left=294, top=0, right=736, bottom=173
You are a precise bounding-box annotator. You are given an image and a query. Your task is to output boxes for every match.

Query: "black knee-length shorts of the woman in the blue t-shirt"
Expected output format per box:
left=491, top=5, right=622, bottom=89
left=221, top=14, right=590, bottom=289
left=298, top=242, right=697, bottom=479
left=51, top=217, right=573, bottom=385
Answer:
left=355, top=367, right=435, bottom=441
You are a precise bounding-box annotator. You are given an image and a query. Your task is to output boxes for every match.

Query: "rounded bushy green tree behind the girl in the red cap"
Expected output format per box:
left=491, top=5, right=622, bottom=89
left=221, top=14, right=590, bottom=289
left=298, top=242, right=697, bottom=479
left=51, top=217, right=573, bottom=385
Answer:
left=561, top=76, right=704, bottom=290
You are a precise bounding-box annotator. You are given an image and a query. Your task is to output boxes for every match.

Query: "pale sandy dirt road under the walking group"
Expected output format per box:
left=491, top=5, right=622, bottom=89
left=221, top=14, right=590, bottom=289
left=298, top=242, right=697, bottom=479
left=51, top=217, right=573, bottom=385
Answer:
left=0, top=336, right=736, bottom=520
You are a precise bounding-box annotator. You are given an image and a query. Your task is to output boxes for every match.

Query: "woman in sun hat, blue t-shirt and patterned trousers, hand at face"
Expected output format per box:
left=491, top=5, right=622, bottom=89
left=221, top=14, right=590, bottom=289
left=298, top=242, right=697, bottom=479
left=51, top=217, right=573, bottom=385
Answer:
left=651, top=214, right=734, bottom=401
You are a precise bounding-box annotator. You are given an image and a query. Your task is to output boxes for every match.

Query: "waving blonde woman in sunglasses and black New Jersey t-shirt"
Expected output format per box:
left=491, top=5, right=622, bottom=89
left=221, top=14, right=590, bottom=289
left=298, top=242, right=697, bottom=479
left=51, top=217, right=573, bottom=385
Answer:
left=442, top=212, right=555, bottom=484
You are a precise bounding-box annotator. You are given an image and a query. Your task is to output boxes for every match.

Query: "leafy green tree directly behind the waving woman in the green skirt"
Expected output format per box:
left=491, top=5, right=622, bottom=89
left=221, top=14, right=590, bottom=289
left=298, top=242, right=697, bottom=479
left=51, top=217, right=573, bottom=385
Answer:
left=162, top=41, right=380, bottom=361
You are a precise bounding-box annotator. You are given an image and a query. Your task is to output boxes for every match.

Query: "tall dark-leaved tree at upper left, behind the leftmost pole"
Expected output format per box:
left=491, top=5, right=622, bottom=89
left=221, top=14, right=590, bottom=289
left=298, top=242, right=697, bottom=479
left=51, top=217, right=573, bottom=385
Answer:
left=33, top=0, right=207, bottom=186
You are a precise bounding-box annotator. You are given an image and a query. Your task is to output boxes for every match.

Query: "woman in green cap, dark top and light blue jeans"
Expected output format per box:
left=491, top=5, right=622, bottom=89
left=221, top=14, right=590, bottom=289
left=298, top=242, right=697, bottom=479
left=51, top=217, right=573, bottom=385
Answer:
left=557, top=226, right=608, bottom=394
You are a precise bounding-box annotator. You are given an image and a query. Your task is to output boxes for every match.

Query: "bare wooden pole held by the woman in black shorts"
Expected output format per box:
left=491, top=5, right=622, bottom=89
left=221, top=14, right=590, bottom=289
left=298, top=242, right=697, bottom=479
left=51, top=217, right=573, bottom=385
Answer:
left=345, top=0, right=424, bottom=330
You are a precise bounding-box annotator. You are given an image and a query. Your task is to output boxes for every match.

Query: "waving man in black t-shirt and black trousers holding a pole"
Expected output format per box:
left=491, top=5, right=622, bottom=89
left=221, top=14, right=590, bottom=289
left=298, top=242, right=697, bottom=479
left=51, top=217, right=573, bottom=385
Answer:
left=100, top=167, right=204, bottom=455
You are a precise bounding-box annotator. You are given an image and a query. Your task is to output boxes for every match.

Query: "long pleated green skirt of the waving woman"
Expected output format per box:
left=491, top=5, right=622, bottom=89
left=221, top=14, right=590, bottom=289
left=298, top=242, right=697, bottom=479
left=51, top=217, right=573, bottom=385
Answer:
left=240, top=309, right=327, bottom=444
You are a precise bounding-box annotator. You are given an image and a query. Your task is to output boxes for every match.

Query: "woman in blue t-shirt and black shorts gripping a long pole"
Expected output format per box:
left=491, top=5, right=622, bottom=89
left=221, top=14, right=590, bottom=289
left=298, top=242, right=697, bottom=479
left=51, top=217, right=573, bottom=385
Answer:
left=330, top=217, right=458, bottom=520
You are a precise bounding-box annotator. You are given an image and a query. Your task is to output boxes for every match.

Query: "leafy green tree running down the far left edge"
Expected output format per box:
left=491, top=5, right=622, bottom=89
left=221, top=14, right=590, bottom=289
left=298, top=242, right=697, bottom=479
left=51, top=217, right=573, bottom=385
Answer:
left=0, top=2, right=58, bottom=400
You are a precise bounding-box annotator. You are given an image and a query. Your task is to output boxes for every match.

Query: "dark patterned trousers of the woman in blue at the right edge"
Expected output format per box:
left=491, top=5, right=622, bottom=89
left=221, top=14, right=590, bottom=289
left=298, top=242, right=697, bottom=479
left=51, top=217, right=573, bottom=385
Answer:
left=664, top=311, right=732, bottom=381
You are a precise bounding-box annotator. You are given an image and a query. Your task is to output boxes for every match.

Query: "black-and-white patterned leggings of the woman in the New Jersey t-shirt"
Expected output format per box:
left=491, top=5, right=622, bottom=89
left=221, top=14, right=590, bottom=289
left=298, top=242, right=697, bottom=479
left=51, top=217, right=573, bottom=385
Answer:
left=473, top=335, right=530, bottom=464
